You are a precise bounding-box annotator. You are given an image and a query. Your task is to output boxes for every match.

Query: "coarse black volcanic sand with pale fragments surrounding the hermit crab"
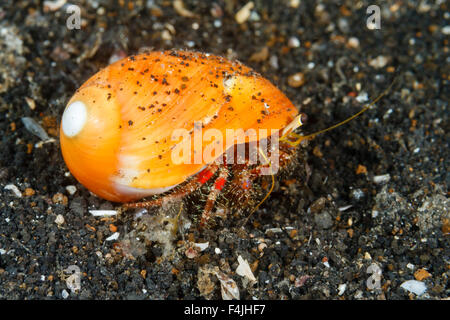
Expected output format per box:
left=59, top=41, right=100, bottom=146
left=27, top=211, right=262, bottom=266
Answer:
left=0, top=0, right=450, bottom=299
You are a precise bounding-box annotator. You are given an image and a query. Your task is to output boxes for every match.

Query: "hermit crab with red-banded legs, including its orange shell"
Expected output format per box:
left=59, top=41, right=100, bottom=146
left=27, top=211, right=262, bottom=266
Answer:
left=60, top=50, right=390, bottom=225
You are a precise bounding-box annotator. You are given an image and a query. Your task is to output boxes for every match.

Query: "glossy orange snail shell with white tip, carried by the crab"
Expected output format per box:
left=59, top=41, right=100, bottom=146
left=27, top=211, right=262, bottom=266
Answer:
left=60, top=51, right=298, bottom=202
